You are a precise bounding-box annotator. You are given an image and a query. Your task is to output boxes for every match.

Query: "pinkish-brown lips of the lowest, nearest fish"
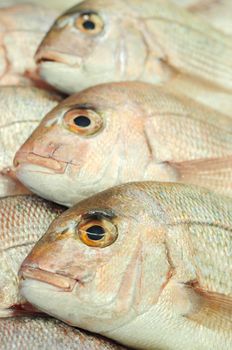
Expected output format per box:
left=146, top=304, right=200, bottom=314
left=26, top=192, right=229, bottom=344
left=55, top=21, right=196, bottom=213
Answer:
left=19, top=265, right=80, bottom=292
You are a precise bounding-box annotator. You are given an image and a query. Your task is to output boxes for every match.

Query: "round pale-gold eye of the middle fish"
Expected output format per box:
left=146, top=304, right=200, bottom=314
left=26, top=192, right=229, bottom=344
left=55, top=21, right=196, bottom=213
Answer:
left=64, top=109, right=103, bottom=136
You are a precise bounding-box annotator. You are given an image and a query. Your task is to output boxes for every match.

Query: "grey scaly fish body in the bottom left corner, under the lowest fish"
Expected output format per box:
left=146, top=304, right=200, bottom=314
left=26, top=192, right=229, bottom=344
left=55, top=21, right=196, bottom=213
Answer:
left=0, top=317, right=126, bottom=350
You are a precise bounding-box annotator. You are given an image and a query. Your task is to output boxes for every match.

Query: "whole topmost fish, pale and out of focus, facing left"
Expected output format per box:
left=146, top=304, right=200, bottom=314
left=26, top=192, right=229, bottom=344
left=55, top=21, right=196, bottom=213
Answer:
left=35, top=0, right=232, bottom=117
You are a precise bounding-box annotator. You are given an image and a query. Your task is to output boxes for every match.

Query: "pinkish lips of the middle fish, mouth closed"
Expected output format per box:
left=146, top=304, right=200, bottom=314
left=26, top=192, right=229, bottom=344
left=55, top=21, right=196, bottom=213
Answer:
left=14, top=151, right=68, bottom=174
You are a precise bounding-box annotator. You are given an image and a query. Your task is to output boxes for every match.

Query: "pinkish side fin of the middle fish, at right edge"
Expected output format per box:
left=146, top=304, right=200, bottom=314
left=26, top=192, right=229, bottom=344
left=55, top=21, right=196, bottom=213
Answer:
left=168, top=157, right=232, bottom=196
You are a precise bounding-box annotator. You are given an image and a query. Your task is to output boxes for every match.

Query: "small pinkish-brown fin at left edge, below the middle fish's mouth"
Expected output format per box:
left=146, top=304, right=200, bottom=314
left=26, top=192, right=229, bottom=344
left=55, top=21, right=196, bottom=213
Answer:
left=0, top=168, right=31, bottom=198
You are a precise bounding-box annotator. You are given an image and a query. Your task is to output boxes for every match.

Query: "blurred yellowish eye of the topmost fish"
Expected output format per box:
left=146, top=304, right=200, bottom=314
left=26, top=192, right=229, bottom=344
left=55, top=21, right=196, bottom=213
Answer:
left=75, top=12, right=104, bottom=35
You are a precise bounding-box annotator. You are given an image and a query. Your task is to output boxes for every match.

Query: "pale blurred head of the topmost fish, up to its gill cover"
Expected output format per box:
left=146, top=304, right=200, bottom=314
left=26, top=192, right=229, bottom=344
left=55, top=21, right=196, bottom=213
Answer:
left=36, top=0, right=165, bottom=94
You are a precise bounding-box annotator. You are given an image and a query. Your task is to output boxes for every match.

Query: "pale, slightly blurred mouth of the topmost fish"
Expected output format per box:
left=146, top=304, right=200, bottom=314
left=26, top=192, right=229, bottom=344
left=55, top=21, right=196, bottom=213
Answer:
left=35, top=49, right=82, bottom=67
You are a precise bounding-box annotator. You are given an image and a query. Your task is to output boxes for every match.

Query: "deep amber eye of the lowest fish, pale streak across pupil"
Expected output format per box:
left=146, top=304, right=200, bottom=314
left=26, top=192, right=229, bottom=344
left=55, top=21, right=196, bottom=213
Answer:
left=77, top=218, right=118, bottom=248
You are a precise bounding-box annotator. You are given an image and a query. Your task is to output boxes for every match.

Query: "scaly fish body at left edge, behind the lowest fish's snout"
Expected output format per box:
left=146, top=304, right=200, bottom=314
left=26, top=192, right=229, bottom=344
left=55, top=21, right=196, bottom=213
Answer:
left=0, top=195, right=64, bottom=314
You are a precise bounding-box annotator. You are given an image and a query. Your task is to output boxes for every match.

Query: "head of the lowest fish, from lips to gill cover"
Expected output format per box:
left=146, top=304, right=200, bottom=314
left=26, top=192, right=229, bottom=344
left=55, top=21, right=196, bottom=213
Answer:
left=20, top=183, right=170, bottom=333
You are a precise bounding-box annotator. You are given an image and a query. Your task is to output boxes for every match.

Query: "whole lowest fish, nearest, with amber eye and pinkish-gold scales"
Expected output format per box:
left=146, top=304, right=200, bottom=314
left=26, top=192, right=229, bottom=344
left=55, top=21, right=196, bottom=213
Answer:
left=19, top=182, right=232, bottom=350
